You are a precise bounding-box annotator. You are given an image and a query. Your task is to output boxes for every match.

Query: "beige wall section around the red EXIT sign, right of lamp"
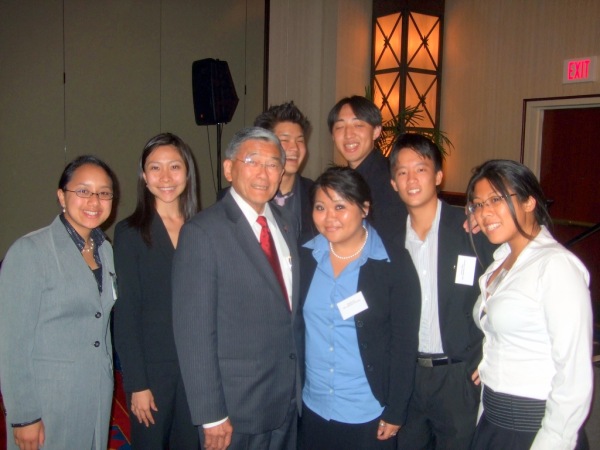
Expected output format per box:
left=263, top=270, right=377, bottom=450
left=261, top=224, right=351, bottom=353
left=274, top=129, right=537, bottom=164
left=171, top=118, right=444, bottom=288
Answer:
left=441, top=0, right=600, bottom=192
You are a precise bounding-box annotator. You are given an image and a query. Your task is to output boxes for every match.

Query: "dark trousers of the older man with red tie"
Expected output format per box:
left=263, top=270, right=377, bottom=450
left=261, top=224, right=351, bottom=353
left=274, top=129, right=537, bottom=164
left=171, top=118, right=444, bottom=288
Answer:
left=199, top=398, right=298, bottom=450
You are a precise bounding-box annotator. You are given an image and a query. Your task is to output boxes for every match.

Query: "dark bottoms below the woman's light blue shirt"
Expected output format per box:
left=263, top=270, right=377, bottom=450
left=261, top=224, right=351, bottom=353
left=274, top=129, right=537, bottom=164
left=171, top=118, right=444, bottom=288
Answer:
left=300, top=405, right=396, bottom=450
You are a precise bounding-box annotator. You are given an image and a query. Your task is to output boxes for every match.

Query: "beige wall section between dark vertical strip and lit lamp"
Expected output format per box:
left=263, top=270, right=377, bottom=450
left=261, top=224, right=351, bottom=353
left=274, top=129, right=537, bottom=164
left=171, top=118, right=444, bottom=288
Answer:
left=269, top=0, right=372, bottom=178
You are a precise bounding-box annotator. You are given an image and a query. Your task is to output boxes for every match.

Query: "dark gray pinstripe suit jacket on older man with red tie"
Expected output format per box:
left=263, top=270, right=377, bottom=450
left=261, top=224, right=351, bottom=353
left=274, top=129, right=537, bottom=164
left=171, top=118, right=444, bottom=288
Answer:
left=172, top=193, right=304, bottom=434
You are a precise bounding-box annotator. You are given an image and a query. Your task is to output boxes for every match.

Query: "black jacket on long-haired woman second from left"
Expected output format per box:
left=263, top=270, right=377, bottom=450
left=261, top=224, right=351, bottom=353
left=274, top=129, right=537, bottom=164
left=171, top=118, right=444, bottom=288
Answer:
left=114, top=214, right=177, bottom=392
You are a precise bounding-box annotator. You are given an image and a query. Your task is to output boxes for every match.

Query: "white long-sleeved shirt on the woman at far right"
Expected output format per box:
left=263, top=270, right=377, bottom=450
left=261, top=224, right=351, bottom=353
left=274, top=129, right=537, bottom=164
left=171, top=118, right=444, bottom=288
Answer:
left=474, top=227, right=593, bottom=450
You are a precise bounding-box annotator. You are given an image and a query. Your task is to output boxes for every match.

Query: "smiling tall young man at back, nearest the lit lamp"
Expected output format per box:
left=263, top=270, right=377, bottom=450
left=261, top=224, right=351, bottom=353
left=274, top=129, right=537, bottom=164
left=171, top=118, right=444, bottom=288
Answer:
left=327, top=95, right=407, bottom=243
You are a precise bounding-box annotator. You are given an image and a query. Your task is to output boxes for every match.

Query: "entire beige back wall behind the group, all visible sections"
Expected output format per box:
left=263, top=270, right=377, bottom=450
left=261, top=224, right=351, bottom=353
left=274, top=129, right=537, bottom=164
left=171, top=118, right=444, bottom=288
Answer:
left=0, top=0, right=600, bottom=257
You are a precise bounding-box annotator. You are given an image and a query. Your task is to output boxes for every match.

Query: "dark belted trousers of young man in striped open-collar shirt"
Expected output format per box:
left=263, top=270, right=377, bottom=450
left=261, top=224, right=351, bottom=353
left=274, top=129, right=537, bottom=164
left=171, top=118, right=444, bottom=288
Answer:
left=398, top=362, right=481, bottom=450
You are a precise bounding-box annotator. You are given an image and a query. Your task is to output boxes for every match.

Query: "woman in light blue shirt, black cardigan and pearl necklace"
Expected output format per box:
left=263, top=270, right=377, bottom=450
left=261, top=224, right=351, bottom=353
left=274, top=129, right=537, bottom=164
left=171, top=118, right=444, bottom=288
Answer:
left=300, top=167, right=420, bottom=450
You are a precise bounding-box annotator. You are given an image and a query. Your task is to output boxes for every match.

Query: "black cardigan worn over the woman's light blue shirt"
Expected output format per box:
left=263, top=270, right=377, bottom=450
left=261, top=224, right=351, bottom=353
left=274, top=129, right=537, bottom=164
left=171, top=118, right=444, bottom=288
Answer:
left=300, top=236, right=421, bottom=425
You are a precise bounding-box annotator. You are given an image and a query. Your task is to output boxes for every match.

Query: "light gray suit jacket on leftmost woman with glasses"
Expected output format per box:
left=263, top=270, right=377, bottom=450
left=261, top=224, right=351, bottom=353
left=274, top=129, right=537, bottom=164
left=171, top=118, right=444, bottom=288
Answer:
left=0, top=217, right=115, bottom=450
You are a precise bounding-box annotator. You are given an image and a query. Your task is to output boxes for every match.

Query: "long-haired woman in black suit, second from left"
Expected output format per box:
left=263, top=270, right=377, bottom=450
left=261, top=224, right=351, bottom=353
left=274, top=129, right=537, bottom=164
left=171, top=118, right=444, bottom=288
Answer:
left=114, top=133, right=200, bottom=450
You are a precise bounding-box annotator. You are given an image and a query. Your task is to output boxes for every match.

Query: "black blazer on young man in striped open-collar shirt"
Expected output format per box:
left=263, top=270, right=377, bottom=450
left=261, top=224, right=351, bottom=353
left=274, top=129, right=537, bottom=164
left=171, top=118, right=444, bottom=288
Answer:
left=395, top=201, right=495, bottom=371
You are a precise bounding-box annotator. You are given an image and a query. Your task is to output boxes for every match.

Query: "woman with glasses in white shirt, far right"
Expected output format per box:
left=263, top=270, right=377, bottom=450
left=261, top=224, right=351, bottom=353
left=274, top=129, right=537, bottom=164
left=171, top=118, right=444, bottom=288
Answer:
left=467, top=160, right=593, bottom=450
